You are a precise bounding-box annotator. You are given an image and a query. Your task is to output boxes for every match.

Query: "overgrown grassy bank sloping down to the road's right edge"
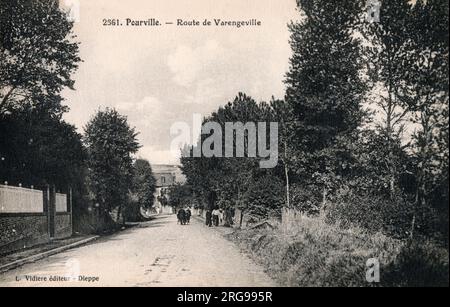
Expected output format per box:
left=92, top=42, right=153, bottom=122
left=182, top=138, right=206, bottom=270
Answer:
left=229, top=218, right=449, bottom=287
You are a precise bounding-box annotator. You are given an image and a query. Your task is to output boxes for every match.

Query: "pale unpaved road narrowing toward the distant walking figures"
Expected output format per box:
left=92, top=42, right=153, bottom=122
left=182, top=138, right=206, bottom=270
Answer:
left=0, top=215, right=276, bottom=287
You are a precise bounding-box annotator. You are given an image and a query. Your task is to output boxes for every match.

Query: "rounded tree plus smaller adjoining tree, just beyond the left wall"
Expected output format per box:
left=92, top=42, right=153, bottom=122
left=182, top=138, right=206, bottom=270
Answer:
left=83, top=109, right=156, bottom=226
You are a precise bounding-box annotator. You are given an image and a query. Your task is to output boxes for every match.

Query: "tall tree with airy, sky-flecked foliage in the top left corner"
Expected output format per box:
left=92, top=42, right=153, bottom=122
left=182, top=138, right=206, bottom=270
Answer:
left=0, top=0, right=80, bottom=115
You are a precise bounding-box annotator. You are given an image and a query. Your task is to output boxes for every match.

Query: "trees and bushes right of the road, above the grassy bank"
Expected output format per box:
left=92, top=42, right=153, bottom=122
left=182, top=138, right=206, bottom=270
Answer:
left=178, top=0, right=449, bottom=244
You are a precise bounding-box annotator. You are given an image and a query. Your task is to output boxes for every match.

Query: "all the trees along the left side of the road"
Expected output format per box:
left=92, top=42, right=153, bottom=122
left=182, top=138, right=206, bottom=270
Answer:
left=0, top=0, right=155, bottom=229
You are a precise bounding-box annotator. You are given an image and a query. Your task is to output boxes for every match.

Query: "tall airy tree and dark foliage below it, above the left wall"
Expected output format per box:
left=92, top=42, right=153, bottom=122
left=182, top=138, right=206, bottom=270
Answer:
left=0, top=0, right=84, bottom=187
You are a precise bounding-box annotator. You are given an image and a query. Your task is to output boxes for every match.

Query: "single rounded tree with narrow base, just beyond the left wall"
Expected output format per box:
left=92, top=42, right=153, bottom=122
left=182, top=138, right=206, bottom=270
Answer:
left=84, top=109, right=140, bottom=225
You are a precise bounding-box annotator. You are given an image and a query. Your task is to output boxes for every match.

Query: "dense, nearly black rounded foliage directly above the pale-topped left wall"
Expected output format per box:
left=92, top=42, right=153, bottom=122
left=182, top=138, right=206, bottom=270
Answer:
left=0, top=109, right=86, bottom=189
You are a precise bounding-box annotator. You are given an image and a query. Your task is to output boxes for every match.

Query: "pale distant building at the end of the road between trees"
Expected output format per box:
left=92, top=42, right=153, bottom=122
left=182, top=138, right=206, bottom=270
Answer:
left=152, top=164, right=186, bottom=214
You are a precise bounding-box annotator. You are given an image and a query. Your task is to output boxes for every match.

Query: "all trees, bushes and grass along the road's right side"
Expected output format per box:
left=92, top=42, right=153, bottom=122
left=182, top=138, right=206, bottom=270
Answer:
left=182, top=0, right=449, bottom=286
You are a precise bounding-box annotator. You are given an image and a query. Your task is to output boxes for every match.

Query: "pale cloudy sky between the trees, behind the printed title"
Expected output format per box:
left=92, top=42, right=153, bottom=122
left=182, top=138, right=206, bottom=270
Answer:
left=62, top=0, right=298, bottom=163
